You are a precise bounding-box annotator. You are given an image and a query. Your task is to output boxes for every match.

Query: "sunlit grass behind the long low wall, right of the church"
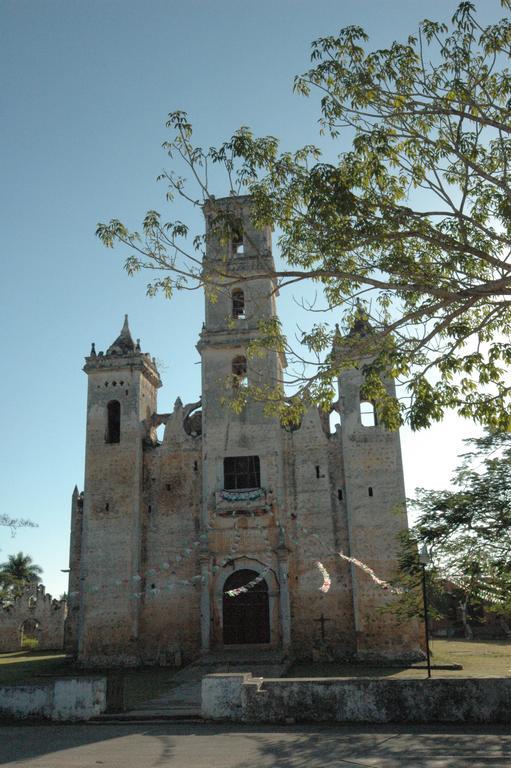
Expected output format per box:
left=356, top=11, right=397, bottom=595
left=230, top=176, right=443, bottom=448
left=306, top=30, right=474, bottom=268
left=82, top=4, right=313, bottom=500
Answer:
left=286, top=640, right=511, bottom=678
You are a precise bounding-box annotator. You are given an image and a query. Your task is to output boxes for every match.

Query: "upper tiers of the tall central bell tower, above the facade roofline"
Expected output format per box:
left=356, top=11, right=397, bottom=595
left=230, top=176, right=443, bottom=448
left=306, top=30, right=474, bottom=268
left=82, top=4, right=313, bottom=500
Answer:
left=199, top=196, right=285, bottom=414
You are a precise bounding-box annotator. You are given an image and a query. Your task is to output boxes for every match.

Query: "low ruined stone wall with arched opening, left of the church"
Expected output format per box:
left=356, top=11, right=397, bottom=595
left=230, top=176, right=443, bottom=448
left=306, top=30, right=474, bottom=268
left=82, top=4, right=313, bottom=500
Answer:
left=0, top=584, right=66, bottom=653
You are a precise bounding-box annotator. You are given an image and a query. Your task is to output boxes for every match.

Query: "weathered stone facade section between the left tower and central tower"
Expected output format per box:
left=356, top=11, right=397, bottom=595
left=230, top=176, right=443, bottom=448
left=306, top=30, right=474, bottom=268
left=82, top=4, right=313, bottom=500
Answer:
left=137, top=400, right=206, bottom=665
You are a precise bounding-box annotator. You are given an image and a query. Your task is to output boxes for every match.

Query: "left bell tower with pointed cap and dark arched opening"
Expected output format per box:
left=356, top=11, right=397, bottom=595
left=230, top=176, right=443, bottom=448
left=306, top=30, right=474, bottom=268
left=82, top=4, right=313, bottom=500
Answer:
left=78, top=316, right=161, bottom=665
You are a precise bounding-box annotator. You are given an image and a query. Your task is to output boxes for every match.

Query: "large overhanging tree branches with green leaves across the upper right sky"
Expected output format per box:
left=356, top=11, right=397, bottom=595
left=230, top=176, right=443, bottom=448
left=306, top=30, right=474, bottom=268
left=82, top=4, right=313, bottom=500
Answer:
left=97, top=0, right=511, bottom=430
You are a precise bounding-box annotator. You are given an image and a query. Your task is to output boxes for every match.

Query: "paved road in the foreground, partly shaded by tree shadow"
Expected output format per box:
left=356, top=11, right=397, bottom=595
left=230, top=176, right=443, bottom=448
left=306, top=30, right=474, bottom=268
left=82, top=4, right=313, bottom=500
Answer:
left=0, top=723, right=511, bottom=768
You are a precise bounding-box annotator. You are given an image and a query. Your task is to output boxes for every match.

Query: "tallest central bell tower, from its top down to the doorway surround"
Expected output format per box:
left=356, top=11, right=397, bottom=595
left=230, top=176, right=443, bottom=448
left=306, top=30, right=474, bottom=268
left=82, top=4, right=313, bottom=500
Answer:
left=198, top=196, right=289, bottom=650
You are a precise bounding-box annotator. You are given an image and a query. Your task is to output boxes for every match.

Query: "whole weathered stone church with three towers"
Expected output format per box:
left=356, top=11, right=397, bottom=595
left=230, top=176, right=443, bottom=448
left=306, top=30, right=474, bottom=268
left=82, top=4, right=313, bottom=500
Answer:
left=66, top=197, right=418, bottom=665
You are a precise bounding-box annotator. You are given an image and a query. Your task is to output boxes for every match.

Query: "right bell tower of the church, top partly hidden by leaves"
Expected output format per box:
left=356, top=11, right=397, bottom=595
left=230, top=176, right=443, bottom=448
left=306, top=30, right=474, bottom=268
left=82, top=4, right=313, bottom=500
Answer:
left=336, top=315, right=417, bottom=659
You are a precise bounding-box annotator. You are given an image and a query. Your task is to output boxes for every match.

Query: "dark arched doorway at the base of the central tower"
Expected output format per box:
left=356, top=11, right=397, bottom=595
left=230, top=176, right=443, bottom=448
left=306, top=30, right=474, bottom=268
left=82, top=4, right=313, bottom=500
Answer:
left=222, top=568, right=270, bottom=645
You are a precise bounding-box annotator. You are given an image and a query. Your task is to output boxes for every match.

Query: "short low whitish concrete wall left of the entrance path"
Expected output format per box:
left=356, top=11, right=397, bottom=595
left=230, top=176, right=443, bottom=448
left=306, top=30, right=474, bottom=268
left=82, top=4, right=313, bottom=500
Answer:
left=0, top=677, right=106, bottom=720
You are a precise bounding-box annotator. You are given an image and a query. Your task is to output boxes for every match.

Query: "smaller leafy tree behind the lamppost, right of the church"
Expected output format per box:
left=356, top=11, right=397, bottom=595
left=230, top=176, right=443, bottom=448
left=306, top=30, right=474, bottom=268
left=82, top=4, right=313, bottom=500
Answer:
left=412, top=433, right=511, bottom=637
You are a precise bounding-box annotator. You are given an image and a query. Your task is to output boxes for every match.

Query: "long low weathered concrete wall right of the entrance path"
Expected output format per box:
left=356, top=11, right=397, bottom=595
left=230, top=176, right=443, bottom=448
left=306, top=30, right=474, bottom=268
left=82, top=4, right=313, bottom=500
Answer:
left=202, top=674, right=511, bottom=723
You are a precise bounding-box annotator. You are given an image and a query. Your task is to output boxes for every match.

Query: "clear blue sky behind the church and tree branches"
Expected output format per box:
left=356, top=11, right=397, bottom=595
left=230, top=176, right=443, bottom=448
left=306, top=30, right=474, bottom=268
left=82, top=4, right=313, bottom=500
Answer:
left=0, top=0, right=501, bottom=594
